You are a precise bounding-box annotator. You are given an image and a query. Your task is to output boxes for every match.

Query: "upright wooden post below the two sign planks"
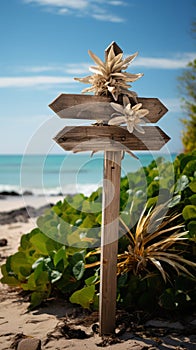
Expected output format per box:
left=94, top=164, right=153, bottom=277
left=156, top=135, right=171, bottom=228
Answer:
left=99, top=151, right=121, bottom=336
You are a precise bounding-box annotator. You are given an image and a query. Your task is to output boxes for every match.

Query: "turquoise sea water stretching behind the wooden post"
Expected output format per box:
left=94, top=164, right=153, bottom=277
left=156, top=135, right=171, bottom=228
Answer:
left=0, top=152, right=176, bottom=195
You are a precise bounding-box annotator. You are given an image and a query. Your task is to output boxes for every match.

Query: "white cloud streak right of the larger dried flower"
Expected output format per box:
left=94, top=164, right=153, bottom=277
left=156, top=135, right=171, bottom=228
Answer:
left=132, top=52, right=196, bottom=69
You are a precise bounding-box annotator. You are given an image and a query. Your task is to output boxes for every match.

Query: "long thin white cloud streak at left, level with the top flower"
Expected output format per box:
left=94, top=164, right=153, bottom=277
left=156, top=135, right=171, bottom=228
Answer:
left=0, top=76, right=73, bottom=88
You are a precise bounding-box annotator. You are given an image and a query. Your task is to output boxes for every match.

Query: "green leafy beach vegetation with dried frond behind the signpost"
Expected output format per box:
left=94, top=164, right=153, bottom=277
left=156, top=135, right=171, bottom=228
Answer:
left=1, top=151, right=196, bottom=312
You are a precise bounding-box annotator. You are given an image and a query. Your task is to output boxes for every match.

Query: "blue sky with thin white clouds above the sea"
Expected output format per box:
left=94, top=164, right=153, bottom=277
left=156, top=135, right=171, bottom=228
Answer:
left=0, top=0, right=196, bottom=154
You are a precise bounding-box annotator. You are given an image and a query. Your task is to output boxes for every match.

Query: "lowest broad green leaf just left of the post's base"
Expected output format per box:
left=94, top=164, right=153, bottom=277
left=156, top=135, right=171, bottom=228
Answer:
left=69, top=285, right=95, bottom=309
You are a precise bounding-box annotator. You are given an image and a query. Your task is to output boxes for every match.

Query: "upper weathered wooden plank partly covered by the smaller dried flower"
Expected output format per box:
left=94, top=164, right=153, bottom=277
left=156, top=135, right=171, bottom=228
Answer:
left=49, top=94, right=168, bottom=123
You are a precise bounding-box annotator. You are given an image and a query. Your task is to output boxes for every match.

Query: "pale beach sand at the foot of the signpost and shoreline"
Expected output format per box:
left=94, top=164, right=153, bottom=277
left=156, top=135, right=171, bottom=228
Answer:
left=0, top=197, right=196, bottom=350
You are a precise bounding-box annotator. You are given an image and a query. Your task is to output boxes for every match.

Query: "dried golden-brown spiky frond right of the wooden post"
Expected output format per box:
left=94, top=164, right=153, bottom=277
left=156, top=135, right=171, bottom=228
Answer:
left=117, top=205, right=196, bottom=281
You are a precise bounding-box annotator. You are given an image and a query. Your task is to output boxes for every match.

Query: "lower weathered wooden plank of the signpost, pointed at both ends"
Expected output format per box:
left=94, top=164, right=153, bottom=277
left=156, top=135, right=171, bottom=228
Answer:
left=54, top=125, right=170, bottom=152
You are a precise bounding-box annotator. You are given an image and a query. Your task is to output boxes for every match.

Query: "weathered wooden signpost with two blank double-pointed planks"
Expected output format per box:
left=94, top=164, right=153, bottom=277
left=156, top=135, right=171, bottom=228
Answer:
left=49, top=43, right=170, bottom=336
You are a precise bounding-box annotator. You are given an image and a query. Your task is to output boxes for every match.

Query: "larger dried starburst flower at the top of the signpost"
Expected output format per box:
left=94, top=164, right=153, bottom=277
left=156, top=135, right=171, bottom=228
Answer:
left=74, top=45, right=143, bottom=101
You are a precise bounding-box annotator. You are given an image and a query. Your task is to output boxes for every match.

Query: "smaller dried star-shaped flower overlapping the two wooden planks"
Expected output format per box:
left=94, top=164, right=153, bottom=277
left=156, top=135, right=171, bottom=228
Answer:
left=108, top=95, right=149, bottom=134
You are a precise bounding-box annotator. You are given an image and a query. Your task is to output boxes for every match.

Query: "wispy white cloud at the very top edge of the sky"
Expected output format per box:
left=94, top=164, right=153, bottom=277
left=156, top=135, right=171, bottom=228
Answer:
left=23, top=0, right=125, bottom=23
